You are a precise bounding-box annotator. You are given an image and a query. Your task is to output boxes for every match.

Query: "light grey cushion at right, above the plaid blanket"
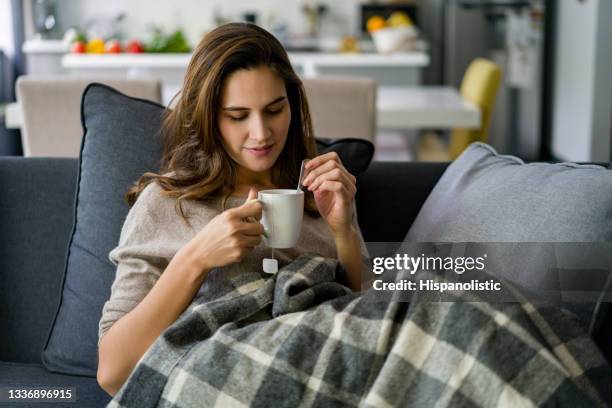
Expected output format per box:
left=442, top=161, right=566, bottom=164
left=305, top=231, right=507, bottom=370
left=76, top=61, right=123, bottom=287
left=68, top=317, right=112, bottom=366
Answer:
left=405, top=143, right=612, bottom=335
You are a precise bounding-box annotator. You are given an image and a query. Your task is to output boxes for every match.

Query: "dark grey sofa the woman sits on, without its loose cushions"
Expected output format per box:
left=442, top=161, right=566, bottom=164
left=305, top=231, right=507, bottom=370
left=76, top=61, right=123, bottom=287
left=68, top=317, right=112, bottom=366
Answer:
left=0, top=157, right=454, bottom=407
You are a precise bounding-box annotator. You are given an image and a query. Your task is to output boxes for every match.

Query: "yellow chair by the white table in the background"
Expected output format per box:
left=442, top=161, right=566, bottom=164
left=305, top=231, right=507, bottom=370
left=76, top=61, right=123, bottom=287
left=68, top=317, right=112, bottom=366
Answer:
left=448, top=58, right=502, bottom=160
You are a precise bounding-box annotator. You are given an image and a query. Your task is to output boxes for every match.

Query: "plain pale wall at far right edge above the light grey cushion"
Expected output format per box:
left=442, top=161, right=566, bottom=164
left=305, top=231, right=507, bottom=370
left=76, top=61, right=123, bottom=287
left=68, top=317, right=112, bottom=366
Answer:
left=552, top=0, right=612, bottom=161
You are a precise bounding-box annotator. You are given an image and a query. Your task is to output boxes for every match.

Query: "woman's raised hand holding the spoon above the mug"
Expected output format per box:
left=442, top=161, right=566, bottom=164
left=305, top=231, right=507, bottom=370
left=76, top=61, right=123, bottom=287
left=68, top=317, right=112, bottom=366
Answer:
left=303, top=152, right=357, bottom=236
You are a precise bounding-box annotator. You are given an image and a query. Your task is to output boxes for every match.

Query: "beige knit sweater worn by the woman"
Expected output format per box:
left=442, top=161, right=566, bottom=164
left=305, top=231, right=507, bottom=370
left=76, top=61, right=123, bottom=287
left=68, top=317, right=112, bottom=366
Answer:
left=98, top=183, right=367, bottom=338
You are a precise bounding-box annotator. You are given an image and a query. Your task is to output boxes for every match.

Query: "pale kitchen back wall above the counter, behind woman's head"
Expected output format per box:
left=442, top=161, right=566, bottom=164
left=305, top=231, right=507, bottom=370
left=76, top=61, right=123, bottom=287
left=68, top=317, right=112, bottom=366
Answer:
left=41, top=0, right=360, bottom=44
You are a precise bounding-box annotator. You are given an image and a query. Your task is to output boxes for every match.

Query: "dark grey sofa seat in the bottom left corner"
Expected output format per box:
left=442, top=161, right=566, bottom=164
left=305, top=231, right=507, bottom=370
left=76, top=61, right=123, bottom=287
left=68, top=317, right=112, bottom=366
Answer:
left=0, top=362, right=111, bottom=408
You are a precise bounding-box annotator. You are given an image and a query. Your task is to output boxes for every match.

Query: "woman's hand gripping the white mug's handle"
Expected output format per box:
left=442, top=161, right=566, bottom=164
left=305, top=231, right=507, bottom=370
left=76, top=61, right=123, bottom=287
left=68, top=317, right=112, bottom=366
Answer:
left=186, top=189, right=264, bottom=271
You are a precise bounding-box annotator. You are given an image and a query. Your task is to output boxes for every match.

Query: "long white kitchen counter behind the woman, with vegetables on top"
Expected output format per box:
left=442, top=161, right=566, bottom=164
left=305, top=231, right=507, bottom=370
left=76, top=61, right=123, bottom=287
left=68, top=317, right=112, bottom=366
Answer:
left=23, top=40, right=430, bottom=103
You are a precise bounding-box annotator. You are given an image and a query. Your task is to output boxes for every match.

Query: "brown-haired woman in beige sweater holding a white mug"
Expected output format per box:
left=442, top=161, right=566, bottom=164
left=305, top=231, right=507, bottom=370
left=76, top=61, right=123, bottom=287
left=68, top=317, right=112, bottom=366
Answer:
left=98, top=23, right=366, bottom=395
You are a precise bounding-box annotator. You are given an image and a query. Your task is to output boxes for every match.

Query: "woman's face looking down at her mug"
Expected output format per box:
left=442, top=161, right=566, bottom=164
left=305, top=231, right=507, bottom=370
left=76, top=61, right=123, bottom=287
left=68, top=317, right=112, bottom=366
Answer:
left=219, top=67, right=291, bottom=181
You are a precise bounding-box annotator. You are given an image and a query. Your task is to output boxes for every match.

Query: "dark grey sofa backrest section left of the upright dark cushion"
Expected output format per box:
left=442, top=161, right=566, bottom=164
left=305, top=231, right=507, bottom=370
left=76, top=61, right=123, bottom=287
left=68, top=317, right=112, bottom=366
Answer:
left=0, top=157, right=78, bottom=363
